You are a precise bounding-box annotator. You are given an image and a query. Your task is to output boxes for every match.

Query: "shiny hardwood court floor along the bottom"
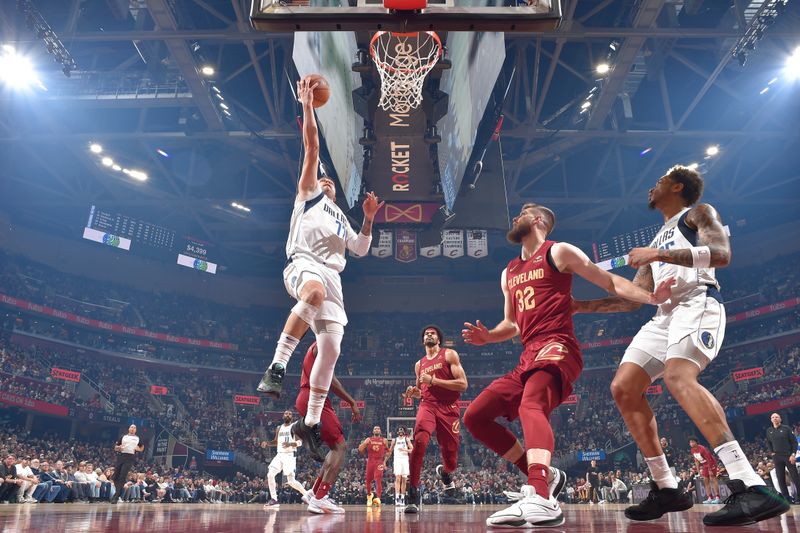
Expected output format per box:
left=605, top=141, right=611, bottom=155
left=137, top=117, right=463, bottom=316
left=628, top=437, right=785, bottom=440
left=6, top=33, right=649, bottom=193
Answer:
left=0, top=504, right=800, bottom=533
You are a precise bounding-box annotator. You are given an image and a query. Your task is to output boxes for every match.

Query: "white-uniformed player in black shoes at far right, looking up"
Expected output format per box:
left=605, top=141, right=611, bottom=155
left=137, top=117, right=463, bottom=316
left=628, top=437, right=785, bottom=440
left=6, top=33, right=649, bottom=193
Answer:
left=573, top=166, right=789, bottom=526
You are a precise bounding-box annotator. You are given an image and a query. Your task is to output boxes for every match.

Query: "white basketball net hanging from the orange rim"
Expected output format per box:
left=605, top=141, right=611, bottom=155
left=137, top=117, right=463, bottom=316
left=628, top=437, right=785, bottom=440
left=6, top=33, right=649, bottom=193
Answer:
left=370, top=31, right=442, bottom=113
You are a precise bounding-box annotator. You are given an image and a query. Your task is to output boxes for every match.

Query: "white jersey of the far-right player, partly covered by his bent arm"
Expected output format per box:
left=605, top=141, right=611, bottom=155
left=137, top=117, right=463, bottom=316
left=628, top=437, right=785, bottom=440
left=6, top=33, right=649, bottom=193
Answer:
left=650, top=207, right=719, bottom=312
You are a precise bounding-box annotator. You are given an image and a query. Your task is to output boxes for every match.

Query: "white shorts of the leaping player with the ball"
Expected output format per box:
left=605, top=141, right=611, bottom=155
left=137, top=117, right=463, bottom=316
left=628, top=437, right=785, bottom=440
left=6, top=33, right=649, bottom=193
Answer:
left=283, top=256, right=347, bottom=326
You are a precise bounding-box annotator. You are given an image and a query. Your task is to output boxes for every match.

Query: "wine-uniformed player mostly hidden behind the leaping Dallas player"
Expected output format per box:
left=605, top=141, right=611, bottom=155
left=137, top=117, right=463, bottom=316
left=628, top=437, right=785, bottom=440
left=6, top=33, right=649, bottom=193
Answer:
left=294, top=343, right=361, bottom=514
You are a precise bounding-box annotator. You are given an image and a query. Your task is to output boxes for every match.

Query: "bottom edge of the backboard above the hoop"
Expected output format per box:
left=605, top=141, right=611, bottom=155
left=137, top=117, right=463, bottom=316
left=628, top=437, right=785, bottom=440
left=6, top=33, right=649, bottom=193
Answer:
left=250, top=0, right=561, bottom=32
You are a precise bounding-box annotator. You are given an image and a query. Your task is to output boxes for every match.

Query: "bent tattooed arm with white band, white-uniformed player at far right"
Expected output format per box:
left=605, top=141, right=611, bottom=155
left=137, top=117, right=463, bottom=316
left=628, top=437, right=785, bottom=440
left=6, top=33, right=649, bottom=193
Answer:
left=628, top=204, right=731, bottom=268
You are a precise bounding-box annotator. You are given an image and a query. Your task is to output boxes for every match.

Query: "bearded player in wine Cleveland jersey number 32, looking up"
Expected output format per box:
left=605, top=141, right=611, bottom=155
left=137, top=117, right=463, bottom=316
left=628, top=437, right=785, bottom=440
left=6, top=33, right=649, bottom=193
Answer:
left=462, top=204, right=672, bottom=528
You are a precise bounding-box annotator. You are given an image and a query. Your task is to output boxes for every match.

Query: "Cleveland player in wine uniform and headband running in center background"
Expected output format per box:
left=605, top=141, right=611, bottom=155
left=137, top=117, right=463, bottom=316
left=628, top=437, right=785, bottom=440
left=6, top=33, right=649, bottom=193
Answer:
left=405, top=326, right=467, bottom=513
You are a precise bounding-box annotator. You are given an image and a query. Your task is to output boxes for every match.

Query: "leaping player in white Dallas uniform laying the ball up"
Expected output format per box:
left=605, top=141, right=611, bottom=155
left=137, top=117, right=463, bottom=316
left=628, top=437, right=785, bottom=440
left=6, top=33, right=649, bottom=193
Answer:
left=258, top=78, right=383, bottom=462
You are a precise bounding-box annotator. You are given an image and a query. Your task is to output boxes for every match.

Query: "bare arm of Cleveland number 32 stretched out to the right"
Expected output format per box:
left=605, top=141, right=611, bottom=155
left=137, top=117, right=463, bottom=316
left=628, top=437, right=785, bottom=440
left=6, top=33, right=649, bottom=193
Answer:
left=551, top=242, right=675, bottom=305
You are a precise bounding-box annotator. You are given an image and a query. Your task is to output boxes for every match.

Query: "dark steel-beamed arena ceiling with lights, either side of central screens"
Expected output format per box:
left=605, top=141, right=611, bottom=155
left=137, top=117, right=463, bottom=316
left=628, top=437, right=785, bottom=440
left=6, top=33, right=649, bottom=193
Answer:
left=0, top=0, right=800, bottom=276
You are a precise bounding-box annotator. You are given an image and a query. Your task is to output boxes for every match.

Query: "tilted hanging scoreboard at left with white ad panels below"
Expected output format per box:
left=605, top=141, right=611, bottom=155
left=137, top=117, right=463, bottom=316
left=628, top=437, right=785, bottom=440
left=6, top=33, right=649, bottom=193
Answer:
left=83, top=205, right=217, bottom=274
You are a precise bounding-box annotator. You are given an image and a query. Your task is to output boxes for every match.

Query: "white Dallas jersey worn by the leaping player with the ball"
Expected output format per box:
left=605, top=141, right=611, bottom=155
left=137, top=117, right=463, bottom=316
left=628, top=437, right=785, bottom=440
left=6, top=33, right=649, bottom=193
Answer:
left=286, top=184, right=357, bottom=272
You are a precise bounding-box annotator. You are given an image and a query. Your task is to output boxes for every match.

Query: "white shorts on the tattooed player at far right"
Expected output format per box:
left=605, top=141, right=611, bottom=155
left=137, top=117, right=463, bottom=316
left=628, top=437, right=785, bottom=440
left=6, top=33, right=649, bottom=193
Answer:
left=622, top=284, right=726, bottom=381
